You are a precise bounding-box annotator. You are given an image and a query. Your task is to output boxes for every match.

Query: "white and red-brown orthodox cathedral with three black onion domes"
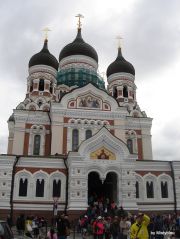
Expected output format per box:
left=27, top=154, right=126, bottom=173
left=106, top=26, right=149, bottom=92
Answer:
left=0, top=17, right=180, bottom=221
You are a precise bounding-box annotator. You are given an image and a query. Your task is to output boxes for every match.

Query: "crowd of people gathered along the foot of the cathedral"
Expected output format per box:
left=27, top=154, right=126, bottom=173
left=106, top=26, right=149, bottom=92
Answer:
left=8, top=198, right=180, bottom=239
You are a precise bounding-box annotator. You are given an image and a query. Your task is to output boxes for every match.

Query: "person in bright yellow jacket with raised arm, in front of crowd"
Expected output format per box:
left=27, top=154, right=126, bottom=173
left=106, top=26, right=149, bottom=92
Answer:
left=130, top=213, right=150, bottom=239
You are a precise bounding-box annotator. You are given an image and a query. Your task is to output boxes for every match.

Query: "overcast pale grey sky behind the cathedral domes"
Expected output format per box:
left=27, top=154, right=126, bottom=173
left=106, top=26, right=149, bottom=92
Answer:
left=0, top=0, right=180, bottom=160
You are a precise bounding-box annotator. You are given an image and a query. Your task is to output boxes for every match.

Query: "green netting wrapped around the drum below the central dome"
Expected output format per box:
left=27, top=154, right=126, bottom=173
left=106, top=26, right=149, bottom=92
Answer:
left=57, top=68, right=105, bottom=90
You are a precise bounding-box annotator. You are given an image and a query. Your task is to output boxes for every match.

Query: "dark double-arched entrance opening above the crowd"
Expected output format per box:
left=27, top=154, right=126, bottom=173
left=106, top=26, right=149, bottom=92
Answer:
left=88, top=172, right=118, bottom=204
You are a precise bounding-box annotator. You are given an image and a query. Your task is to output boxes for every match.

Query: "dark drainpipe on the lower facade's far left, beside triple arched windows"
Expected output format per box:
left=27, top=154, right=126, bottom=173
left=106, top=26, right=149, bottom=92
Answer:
left=9, top=155, right=20, bottom=224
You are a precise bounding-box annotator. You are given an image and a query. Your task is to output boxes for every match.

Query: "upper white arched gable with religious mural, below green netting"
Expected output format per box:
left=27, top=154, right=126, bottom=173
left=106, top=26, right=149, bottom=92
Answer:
left=61, top=84, right=118, bottom=111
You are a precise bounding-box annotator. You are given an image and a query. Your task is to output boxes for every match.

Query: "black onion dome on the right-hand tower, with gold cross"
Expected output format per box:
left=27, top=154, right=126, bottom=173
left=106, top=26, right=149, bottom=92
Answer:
left=106, top=48, right=135, bottom=77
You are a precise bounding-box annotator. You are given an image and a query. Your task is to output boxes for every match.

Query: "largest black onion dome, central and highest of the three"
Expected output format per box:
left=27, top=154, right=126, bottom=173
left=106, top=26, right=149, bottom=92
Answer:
left=59, top=28, right=98, bottom=62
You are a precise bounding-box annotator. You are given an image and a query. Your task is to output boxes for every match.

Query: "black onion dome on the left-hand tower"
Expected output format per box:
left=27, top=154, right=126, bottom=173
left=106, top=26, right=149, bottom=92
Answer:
left=29, top=39, right=59, bottom=70
